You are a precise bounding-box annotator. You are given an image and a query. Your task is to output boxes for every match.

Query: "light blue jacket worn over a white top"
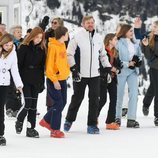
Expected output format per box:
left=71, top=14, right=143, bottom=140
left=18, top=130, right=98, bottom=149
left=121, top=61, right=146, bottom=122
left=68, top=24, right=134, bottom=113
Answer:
left=116, top=38, right=142, bottom=75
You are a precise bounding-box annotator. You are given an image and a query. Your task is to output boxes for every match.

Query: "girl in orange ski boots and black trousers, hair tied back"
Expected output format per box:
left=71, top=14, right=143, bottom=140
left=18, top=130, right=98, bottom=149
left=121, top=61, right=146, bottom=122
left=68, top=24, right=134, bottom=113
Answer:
left=98, top=33, right=121, bottom=130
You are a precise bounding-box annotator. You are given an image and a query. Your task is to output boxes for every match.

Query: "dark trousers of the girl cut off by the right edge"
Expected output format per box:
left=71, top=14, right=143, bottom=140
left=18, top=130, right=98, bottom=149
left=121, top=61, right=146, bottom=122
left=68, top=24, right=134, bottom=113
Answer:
left=150, top=68, right=158, bottom=118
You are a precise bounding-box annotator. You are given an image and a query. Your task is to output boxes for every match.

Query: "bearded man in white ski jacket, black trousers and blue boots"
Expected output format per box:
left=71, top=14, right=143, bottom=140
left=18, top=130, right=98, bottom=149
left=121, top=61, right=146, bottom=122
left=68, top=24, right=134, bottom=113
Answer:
left=64, top=16, right=111, bottom=134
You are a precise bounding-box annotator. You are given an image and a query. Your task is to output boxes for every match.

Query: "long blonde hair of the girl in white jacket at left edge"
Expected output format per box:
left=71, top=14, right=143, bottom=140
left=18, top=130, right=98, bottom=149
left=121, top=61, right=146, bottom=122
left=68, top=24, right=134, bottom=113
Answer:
left=0, top=33, right=13, bottom=58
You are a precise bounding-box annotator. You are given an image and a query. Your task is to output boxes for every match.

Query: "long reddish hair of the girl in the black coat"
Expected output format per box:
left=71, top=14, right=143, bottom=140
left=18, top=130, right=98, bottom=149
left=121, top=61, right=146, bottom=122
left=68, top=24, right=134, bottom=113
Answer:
left=22, top=27, right=46, bottom=49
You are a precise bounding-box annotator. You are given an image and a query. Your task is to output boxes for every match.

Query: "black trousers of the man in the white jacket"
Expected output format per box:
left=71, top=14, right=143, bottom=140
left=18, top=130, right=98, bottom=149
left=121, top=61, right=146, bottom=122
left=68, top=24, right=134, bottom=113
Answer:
left=66, top=77, right=100, bottom=126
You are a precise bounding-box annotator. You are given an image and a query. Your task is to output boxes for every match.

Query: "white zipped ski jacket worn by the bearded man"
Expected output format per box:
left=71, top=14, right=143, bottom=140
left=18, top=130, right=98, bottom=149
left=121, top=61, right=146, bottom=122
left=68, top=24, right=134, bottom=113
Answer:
left=67, top=28, right=111, bottom=78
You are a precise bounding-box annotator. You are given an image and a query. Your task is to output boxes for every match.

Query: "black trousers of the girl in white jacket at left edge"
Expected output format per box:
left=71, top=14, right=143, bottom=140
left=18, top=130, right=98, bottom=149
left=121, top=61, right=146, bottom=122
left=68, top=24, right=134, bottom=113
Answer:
left=0, top=86, right=8, bottom=136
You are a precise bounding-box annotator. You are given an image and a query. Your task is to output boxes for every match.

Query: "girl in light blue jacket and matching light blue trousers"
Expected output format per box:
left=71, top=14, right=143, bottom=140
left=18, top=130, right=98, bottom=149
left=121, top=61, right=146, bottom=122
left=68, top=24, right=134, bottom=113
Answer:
left=116, top=24, right=141, bottom=128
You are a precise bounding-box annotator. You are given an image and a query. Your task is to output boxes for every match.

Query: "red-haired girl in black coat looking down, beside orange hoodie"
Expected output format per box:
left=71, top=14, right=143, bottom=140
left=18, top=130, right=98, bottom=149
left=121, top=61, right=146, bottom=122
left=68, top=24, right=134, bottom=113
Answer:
left=15, top=27, right=45, bottom=138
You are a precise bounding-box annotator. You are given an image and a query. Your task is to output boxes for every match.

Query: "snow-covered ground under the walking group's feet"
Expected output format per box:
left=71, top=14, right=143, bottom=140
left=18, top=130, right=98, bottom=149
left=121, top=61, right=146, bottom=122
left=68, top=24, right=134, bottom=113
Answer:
left=0, top=86, right=158, bottom=158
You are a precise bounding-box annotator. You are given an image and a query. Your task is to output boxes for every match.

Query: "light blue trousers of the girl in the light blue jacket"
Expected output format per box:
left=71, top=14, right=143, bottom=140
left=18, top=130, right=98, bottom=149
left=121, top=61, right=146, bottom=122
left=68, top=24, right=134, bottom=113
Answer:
left=116, top=71, right=138, bottom=120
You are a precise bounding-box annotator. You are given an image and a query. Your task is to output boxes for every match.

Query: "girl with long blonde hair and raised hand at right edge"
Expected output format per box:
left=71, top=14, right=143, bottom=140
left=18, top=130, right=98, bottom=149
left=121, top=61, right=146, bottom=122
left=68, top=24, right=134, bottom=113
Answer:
left=142, top=21, right=158, bottom=126
